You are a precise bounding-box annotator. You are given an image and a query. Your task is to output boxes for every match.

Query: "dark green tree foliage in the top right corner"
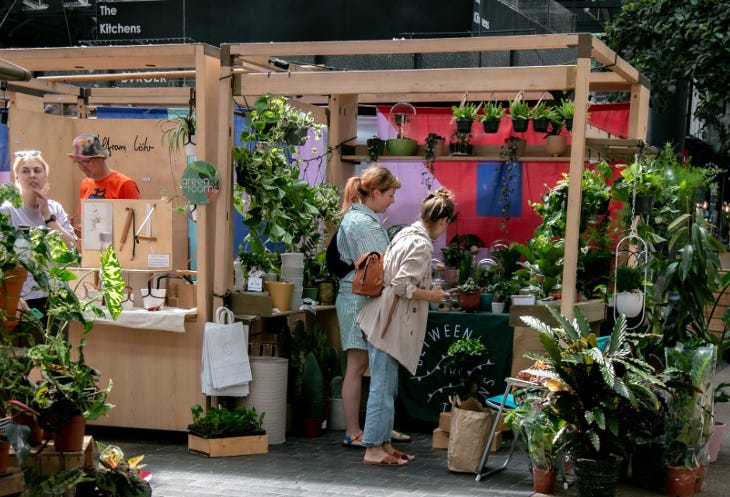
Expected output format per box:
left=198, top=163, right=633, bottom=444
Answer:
left=606, top=0, right=730, bottom=152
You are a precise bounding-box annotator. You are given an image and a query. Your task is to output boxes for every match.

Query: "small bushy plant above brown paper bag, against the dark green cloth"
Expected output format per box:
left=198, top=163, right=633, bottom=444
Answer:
left=443, top=338, right=489, bottom=400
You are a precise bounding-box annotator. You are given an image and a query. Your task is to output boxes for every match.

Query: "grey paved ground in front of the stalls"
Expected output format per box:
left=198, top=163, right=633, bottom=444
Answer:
left=82, top=367, right=730, bottom=497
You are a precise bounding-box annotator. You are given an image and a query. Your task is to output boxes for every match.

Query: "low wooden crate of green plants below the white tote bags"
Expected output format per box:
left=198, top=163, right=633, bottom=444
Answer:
left=188, top=404, right=268, bottom=457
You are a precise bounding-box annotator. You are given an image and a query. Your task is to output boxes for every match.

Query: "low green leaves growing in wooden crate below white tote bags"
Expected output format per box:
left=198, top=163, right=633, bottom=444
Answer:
left=188, top=404, right=266, bottom=437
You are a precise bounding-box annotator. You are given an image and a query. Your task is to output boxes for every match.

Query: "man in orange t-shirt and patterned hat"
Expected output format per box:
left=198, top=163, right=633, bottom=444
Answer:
left=68, top=133, right=141, bottom=199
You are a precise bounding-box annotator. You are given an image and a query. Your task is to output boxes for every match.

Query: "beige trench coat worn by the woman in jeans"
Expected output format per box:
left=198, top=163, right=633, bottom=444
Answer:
left=358, top=221, right=433, bottom=374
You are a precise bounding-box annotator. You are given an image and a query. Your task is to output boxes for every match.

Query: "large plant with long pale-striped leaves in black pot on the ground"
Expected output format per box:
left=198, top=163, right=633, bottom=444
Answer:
left=522, top=307, right=664, bottom=496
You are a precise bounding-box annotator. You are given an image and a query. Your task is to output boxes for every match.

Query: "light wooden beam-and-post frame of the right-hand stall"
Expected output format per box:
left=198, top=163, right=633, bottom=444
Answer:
left=216, top=33, right=649, bottom=317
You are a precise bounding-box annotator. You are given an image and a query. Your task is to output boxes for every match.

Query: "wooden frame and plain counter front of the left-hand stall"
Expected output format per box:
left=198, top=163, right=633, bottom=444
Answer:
left=0, top=44, right=222, bottom=431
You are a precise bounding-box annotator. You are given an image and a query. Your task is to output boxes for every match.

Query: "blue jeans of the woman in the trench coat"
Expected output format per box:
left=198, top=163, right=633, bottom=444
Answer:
left=362, top=343, right=398, bottom=447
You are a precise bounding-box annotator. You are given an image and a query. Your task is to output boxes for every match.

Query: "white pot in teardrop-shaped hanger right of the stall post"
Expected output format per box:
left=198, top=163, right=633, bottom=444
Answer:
left=613, top=151, right=649, bottom=330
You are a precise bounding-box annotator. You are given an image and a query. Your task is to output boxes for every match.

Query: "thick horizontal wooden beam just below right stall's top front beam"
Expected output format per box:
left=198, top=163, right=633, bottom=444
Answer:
left=235, top=66, right=575, bottom=100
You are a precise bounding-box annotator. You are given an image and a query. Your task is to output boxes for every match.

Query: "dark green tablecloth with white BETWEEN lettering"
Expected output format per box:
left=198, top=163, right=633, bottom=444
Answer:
left=398, top=311, right=513, bottom=423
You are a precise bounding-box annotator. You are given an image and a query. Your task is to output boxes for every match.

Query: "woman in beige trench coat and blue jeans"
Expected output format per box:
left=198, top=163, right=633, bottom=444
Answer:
left=358, top=188, right=454, bottom=466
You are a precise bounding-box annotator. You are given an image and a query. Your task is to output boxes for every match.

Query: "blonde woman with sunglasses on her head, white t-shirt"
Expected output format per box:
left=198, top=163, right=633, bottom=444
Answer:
left=0, top=150, right=76, bottom=330
